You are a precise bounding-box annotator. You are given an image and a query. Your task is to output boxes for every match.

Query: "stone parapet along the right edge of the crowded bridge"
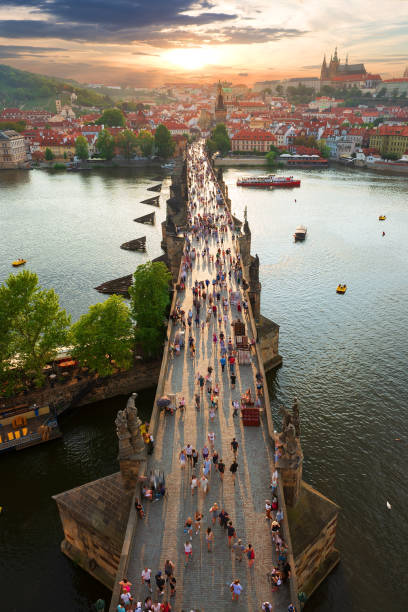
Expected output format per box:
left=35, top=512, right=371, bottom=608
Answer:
left=207, top=152, right=298, bottom=606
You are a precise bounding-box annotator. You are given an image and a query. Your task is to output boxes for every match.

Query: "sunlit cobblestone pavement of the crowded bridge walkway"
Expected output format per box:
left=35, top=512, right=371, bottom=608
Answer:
left=128, top=148, right=289, bottom=612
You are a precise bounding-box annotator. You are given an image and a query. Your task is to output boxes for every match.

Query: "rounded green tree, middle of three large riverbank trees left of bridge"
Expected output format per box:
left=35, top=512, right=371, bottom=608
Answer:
left=71, top=295, right=133, bottom=376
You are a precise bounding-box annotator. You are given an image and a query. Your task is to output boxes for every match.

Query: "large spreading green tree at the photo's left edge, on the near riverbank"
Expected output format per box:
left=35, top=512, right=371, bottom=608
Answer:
left=0, top=270, right=70, bottom=381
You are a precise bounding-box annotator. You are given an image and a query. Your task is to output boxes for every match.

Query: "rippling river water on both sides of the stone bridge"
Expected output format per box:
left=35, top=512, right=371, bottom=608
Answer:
left=0, top=169, right=408, bottom=612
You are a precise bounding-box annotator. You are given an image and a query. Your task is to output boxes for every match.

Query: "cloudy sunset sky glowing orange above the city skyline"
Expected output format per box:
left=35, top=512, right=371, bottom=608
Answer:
left=0, top=0, right=408, bottom=87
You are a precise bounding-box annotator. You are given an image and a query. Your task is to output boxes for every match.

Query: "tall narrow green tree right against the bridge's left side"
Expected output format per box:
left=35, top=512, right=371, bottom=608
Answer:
left=129, top=261, right=171, bottom=357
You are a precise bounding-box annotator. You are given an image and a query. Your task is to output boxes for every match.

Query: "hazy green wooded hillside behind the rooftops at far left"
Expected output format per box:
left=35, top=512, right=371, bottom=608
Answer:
left=0, top=64, right=113, bottom=111
